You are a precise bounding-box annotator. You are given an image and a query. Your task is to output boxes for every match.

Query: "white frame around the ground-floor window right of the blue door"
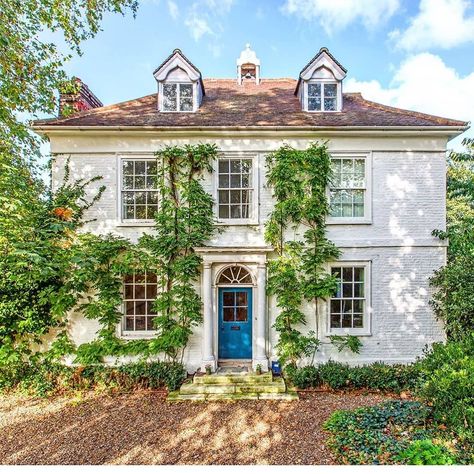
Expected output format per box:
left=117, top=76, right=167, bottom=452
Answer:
left=325, top=260, right=372, bottom=337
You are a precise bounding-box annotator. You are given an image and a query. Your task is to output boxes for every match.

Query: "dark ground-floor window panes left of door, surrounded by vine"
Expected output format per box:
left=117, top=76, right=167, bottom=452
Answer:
left=123, top=272, right=158, bottom=333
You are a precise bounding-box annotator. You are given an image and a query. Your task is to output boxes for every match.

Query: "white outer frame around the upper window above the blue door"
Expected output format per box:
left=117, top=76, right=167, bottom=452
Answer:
left=212, top=152, right=260, bottom=225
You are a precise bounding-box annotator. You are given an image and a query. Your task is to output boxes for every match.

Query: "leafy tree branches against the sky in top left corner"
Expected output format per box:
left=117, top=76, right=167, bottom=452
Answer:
left=0, top=0, right=138, bottom=161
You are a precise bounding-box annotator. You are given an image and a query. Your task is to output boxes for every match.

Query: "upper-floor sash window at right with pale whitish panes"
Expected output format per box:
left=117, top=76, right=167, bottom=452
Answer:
left=329, top=156, right=370, bottom=223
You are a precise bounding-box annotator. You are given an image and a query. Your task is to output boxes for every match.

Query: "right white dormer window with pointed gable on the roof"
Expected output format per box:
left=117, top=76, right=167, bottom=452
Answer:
left=295, top=48, right=347, bottom=112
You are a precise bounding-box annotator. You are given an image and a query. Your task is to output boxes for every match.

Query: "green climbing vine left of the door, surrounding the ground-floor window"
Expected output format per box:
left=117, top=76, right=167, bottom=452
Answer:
left=76, top=144, right=217, bottom=363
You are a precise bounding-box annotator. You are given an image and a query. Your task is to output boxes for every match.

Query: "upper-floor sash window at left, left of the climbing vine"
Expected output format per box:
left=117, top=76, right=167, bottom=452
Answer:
left=120, top=158, right=158, bottom=220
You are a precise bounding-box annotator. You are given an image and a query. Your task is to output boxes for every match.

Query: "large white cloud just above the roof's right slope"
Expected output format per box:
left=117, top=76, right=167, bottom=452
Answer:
left=344, top=53, right=474, bottom=147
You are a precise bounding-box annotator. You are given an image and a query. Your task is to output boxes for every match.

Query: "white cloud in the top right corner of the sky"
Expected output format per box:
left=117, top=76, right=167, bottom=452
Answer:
left=389, top=0, right=474, bottom=51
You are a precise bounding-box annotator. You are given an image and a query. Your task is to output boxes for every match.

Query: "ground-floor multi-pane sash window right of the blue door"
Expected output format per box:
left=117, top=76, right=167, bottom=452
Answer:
left=329, top=263, right=369, bottom=333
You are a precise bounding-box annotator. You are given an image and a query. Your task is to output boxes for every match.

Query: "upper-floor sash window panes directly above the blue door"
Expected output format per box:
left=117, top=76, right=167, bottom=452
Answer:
left=217, top=158, right=254, bottom=220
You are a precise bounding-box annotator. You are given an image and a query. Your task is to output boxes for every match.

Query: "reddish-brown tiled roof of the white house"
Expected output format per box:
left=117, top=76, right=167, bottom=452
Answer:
left=35, top=79, right=467, bottom=128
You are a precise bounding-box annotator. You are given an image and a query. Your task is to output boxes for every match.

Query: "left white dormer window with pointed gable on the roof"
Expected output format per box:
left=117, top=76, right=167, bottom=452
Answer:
left=153, top=49, right=205, bottom=112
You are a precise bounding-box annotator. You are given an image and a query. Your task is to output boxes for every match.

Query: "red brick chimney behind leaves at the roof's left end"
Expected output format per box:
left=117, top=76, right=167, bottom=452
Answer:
left=59, top=77, right=103, bottom=117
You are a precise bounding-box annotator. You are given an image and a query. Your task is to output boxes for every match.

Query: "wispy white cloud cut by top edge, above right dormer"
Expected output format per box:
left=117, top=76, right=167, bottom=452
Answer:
left=282, top=0, right=400, bottom=34
